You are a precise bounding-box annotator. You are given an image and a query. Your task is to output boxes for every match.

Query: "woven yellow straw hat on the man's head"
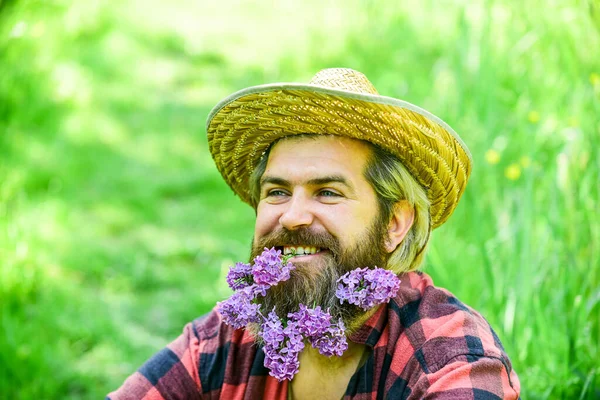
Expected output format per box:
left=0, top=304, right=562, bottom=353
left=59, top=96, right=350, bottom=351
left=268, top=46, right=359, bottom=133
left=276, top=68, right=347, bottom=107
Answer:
left=206, top=68, right=472, bottom=228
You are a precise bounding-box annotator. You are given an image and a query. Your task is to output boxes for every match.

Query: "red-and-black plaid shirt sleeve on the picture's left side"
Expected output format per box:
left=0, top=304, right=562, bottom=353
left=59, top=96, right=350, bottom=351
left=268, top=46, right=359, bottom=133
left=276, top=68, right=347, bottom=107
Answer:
left=106, top=324, right=202, bottom=400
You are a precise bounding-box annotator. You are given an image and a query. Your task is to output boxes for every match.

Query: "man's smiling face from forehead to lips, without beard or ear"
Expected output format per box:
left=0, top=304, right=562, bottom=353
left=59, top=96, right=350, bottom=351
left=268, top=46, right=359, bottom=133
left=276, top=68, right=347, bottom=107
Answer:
left=254, top=136, right=378, bottom=263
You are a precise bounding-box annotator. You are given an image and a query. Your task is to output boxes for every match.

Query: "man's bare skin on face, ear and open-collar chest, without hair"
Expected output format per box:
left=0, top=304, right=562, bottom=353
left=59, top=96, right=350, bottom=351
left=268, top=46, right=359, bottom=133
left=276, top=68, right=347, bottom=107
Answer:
left=254, top=136, right=414, bottom=399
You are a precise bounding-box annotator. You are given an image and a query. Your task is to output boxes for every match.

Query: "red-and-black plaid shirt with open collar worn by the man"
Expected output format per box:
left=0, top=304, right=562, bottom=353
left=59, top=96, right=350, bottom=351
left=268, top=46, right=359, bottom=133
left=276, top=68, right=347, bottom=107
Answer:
left=108, top=272, right=520, bottom=400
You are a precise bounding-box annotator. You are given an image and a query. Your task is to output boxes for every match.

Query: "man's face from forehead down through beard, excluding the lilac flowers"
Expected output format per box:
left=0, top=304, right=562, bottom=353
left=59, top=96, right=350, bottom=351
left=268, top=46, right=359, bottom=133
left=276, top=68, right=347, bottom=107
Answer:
left=252, top=136, right=388, bottom=322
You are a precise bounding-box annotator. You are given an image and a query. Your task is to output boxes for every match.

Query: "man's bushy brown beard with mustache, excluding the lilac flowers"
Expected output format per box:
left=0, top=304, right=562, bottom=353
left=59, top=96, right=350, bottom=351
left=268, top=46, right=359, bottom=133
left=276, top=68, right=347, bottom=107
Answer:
left=250, top=218, right=389, bottom=333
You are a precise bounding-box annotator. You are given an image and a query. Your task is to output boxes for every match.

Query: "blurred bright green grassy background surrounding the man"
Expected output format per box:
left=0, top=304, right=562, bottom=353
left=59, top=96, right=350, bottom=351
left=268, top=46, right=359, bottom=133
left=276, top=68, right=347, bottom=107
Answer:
left=0, top=0, right=600, bottom=399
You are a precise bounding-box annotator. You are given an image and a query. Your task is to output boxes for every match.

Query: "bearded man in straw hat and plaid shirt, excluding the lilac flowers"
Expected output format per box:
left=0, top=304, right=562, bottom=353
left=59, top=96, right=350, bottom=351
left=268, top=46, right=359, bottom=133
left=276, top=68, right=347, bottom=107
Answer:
left=109, top=69, right=520, bottom=400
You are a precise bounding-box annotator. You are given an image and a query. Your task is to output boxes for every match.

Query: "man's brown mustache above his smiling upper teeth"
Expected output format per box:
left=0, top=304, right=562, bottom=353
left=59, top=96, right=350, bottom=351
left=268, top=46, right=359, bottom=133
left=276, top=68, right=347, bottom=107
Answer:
left=255, top=227, right=341, bottom=254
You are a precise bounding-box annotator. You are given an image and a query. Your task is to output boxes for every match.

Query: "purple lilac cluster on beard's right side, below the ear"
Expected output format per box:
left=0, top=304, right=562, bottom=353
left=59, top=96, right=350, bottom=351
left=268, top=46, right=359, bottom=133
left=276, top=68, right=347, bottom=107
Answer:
left=335, top=267, right=400, bottom=310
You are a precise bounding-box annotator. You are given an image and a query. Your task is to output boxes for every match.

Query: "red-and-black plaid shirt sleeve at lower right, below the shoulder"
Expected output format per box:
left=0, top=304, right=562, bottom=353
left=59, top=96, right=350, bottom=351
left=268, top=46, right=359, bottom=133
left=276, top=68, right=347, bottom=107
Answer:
left=411, top=355, right=520, bottom=400
